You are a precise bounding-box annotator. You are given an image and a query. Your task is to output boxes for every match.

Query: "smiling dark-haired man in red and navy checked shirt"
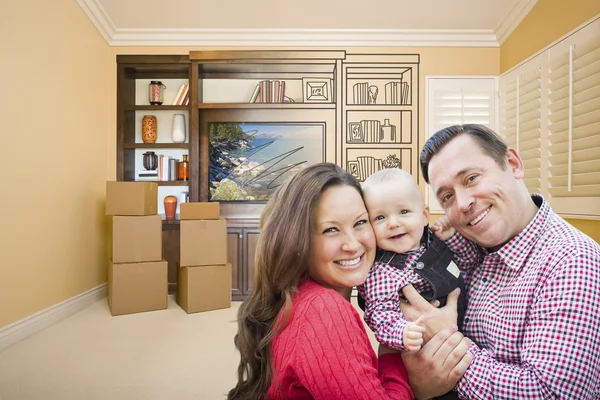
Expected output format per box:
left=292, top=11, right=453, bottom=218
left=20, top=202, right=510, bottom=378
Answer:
left=402, top=125, right=600, bottom=400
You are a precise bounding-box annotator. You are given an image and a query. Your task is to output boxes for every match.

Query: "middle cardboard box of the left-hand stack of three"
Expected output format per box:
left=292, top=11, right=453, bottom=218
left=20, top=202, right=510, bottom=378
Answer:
left=106, top=214, right=162, bottom=263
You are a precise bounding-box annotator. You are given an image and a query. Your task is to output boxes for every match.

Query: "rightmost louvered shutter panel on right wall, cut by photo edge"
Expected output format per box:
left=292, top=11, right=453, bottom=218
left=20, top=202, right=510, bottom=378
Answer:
left=548, top=24, right=600, bottom=197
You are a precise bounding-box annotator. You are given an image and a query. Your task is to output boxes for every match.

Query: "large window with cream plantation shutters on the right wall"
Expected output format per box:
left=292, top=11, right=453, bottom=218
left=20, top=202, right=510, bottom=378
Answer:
left=500, top=19, right=600, bottom=218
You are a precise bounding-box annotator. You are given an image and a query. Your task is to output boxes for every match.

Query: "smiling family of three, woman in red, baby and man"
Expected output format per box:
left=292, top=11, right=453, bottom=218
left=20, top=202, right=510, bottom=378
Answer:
left=228, top=125, right=600, bottom=400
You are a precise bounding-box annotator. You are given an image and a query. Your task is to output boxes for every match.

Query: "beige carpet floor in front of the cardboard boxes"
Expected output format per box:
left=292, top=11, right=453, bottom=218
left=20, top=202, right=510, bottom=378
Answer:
left=0, top=296, right=374, bottom=400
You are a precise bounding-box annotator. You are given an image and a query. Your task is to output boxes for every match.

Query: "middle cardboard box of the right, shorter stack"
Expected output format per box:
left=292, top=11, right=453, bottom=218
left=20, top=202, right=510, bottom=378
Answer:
left=179, top=218, right=227, bottom=267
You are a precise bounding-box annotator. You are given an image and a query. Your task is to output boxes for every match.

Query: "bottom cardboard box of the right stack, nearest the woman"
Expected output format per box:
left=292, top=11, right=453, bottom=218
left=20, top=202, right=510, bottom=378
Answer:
left=177, top=264, right=231, bottom=314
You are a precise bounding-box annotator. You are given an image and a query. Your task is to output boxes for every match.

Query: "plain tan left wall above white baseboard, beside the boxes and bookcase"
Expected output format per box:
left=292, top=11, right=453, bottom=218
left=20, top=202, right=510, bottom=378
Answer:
left=0, top=0, right=114, bottom=327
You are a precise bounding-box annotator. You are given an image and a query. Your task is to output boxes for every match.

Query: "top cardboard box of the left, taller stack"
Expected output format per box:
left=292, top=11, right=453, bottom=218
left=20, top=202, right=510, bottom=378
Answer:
left=106, top=181, right=158, bottom=215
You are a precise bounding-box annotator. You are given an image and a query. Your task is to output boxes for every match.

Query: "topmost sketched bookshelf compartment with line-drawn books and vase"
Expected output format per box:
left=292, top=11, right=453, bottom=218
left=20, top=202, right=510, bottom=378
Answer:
left=347, top=68, right=412, bottom=105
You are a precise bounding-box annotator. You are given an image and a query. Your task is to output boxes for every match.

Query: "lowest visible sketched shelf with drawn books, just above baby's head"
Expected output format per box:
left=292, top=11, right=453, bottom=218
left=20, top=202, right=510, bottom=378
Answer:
left=346, top=149, right=412, bottom=182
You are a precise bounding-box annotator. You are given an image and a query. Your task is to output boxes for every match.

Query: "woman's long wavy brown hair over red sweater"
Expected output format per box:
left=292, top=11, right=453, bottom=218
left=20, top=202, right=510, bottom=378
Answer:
left=227, top=163, right=362, bottom=400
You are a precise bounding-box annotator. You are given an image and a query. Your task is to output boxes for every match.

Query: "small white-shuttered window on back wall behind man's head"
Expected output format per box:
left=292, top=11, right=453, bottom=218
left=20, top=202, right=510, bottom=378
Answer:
left=425, top=76, right=498, bottom=214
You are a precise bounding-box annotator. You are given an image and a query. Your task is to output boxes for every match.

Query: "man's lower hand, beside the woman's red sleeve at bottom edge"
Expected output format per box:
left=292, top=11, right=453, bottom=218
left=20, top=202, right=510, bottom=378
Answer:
left=402, top=327, right=473, bottom=399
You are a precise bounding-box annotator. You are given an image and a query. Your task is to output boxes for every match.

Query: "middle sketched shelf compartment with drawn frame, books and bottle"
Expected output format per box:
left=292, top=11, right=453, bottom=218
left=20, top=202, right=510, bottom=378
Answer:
left=346, top=111, right=412, bottom=144
